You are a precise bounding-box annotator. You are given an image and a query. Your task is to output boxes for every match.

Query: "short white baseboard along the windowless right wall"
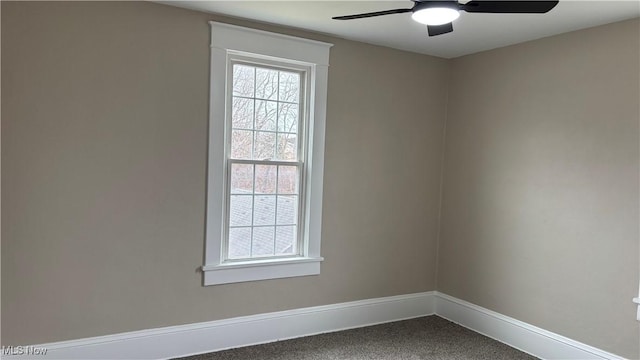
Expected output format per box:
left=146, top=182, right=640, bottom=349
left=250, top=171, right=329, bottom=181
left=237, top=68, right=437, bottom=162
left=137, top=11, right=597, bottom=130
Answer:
left=435, top=292, right=623, bottom=360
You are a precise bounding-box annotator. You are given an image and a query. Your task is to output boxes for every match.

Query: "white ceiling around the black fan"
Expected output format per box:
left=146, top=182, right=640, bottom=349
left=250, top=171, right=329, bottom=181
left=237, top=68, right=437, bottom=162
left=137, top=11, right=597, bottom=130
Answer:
left=161, top=0, right=640, bottom=58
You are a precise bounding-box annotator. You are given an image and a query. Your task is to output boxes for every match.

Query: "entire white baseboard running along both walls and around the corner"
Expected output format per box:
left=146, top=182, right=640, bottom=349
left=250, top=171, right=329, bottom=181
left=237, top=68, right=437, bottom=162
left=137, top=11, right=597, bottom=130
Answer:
left=2, top=291, right=622, bottom=360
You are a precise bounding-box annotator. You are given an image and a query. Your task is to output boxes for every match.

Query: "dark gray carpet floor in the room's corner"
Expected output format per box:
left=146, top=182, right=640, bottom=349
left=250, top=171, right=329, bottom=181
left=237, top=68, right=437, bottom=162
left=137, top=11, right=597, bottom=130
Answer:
left=175, top=316, right=536, bottom=360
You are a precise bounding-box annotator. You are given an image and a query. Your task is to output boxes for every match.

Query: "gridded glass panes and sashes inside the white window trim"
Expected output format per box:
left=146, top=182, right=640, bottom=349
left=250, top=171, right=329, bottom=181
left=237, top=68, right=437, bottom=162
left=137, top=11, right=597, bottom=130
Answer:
left=222, top=56, right=308, bottom=262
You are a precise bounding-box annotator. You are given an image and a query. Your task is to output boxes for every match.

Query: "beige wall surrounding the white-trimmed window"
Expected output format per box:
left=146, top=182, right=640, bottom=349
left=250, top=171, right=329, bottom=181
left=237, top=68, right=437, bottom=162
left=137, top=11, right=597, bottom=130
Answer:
left=2, top=1, right=449, bottom=345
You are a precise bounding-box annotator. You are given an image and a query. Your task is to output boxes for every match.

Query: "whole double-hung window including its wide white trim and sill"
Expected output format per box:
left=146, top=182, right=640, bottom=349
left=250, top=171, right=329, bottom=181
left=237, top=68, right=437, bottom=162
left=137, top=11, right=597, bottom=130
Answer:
left=203, top=22, right=331, bottom=285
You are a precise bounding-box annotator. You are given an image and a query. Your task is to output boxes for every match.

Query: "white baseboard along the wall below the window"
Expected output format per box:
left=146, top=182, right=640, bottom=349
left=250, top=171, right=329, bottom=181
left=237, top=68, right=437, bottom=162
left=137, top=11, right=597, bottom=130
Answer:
left=3, top=292, right=434, bottom=360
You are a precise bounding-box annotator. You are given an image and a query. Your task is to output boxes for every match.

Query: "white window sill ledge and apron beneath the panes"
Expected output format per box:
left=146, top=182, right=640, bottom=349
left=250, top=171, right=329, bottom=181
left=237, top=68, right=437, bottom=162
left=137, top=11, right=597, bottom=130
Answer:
left=202, top=257, right=324, bottom=286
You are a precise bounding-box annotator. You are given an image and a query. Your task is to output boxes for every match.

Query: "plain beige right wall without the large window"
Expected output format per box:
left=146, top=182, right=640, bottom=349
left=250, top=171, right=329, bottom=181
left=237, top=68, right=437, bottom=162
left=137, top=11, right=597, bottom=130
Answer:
left=437, top=20, right=640, bottom=359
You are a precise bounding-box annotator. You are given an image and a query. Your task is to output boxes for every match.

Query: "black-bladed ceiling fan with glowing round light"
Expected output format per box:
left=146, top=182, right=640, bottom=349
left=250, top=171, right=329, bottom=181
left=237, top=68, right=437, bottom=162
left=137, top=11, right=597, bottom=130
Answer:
left=332, top=0, right=558, bottom=36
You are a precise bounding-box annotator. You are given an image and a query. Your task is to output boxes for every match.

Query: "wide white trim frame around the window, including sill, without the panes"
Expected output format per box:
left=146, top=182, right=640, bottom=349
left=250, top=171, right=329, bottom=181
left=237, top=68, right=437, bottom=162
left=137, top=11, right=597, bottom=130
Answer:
left=202, top=21, right=333, bottom=286
